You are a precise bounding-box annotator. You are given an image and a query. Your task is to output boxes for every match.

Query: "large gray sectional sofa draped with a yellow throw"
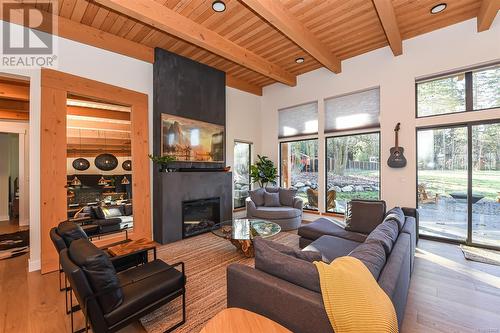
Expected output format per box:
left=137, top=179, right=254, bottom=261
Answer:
left=227, top=203, right=418, bottom=333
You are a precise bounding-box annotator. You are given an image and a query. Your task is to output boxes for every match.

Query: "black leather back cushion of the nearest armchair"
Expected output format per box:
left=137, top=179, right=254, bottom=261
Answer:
left=69, top=239, right=123, bottom=313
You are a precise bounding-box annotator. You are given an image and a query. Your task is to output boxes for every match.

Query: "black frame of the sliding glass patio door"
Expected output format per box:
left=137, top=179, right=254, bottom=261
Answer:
left=414, top=117, right=500, bottom=251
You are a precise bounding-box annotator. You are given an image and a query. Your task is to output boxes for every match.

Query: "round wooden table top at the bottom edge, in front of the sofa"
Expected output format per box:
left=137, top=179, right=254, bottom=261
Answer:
left=200, top=308, right=292, bottom=333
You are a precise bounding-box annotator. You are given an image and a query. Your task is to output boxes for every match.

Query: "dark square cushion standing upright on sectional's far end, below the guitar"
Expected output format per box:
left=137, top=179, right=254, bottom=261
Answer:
left=345, top=200, right=386, bottom=234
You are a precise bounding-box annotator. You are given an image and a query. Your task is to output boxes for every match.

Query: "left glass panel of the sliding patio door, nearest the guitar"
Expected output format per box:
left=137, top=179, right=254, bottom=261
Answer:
left=417, top=127, right=468, bottom=241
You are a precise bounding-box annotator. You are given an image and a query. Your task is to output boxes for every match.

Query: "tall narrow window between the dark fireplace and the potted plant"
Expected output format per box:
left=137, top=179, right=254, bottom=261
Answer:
left=233, top=141, right=252, bottom=208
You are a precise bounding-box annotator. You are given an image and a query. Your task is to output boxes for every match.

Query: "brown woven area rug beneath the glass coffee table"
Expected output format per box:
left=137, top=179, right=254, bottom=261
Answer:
left=140, top=232, right=299, bottom=333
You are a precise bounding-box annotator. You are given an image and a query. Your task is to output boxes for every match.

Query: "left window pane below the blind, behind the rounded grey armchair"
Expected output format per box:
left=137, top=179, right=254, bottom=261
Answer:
left=280, top=139, right=318, bottom=210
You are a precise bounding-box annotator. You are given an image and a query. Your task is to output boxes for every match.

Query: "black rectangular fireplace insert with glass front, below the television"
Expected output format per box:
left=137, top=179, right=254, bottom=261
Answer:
left=182, top=198, right=220, bottom=238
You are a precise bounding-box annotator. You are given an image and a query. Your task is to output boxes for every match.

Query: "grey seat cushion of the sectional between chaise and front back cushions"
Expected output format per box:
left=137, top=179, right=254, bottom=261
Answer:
left=303, top=235, right=359, bottom=263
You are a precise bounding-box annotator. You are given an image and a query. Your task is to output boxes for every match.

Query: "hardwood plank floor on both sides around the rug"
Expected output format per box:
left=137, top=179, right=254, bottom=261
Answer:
left=0, top=240, right=500, bottom=333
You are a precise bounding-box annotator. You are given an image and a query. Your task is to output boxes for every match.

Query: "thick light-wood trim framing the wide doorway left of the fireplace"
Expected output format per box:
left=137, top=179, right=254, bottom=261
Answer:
left=40, top=69, right=151, bottom=274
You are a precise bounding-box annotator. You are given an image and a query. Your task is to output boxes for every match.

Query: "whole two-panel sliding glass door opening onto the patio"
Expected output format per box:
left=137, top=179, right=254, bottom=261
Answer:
left=417, top=122, right=500, bottom=248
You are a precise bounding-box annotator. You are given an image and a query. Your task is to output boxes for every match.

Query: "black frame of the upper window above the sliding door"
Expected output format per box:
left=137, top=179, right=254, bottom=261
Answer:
left=415, top=62, right=500, bottom=119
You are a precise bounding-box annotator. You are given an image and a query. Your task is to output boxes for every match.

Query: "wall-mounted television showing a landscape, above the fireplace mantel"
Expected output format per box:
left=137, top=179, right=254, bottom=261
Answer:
left=161, top=113, right=224, bottom=163
